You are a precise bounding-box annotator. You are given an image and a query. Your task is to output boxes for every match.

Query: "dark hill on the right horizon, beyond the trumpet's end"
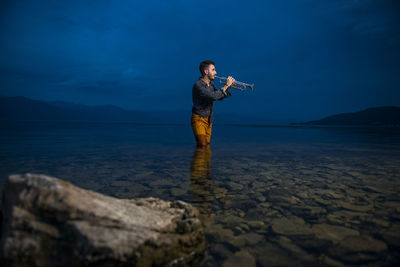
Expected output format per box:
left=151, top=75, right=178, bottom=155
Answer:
left=292, top=106, right=400, bottom=126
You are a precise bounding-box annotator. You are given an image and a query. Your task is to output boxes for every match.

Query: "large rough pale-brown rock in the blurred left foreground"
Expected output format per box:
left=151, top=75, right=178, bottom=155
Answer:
left=0, top=174, right=204, bottom=266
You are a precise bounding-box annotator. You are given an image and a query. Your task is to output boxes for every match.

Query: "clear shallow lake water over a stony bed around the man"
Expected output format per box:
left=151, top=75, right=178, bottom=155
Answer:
left=0, top=122, right=400, bottom=266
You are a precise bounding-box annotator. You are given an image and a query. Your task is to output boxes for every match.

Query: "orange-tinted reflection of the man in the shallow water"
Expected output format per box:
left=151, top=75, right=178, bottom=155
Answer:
left=190, top=145, right=213, bottom=226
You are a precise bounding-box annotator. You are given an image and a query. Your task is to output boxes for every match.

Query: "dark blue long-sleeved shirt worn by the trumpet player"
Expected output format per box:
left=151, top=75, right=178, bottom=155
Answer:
left=192, top=78, right=231, bottom=121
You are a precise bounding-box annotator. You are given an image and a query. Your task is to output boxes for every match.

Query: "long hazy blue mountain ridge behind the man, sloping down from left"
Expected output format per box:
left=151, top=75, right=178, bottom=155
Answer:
left=0, top=96, right=272, bottom=124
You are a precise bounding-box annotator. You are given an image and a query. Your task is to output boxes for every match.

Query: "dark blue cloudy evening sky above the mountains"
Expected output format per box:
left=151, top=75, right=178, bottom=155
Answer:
left=0, top=0, right=400, bottom=122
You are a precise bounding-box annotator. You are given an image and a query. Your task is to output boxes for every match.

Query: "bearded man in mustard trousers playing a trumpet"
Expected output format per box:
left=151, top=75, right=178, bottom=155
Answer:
left=191, top=60, right=235, bottom=148
